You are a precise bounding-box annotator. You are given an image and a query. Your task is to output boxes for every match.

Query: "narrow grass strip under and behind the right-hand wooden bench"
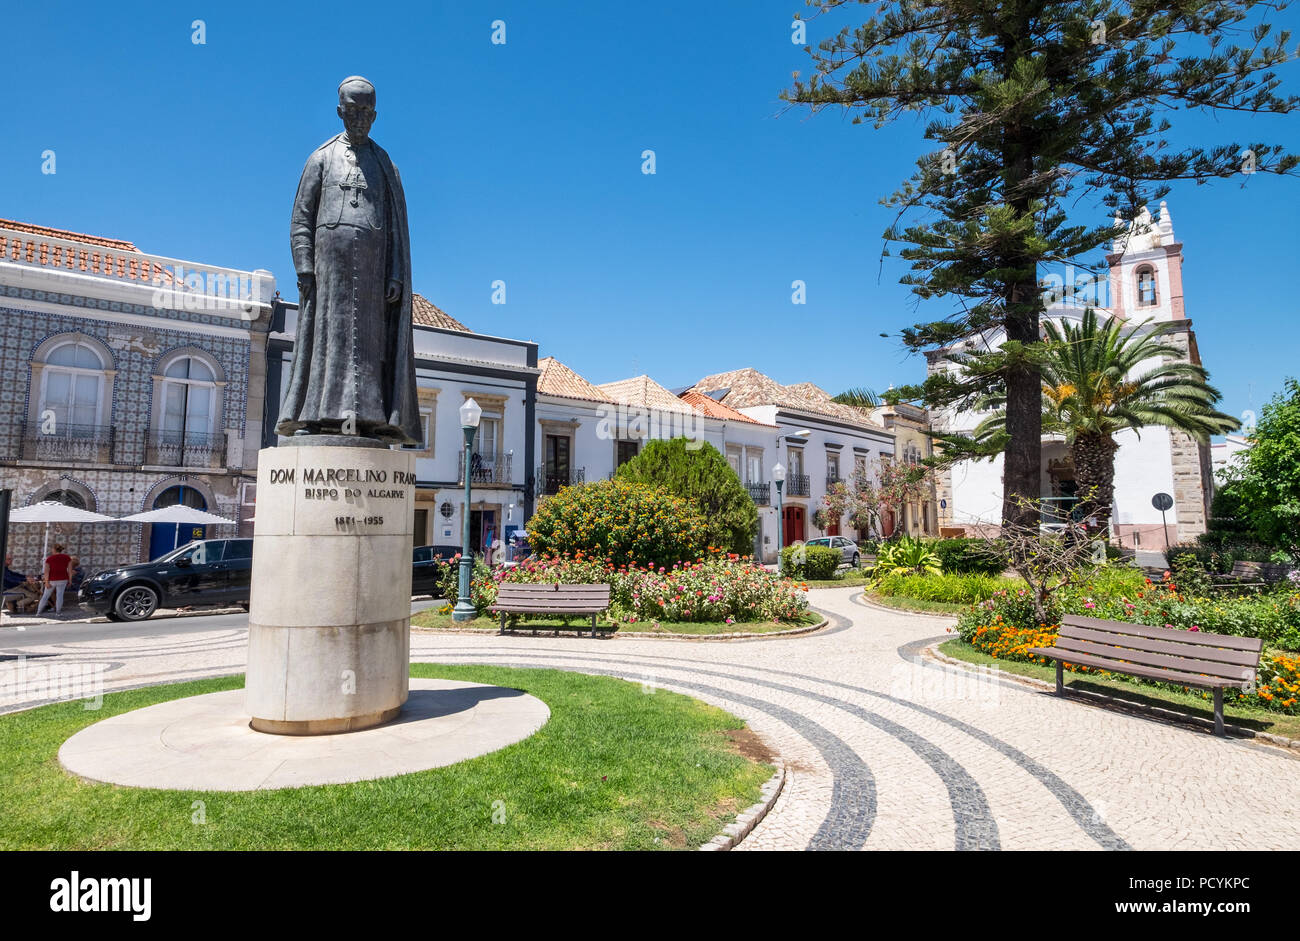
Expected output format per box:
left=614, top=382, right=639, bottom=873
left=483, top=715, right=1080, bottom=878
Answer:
left=939, top=638, right=1300, bottom=738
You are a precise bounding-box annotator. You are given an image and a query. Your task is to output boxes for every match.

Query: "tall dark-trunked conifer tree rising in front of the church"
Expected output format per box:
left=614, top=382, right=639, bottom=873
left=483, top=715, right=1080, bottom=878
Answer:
left=783, top=0, right=1300, bottom=525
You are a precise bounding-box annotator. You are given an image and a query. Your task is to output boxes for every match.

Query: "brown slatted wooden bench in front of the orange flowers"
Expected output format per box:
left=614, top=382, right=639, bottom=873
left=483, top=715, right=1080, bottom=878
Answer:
left=1030, top=615, right=1264, bottom=736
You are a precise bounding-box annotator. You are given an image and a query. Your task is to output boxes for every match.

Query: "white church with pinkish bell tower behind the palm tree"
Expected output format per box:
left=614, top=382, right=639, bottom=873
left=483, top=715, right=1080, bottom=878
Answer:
left=927, top=203, right=1213, bottom=548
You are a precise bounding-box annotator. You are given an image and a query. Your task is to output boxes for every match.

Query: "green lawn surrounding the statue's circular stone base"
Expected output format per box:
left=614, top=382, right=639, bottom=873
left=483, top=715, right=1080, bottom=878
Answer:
left=0, top=664, right=772, bottom=850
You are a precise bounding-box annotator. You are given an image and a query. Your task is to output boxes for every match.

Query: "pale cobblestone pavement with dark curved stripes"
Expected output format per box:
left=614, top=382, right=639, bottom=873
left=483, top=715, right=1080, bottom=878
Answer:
left=0, top=589, right=1300, bottom=850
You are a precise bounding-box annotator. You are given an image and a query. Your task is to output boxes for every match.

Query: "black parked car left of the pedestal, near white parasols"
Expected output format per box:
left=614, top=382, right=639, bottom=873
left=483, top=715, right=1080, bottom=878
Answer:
left=78, top=539, right=252, bottom=621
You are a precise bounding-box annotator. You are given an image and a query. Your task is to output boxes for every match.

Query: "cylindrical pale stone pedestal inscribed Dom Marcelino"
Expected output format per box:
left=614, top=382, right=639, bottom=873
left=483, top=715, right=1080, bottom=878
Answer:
left=244, top=435, right=415, bottom=734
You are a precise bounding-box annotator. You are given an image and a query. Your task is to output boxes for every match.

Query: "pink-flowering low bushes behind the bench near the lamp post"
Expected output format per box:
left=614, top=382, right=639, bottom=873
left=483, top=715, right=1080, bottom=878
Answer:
left=498, top=554, right=807, bottom=624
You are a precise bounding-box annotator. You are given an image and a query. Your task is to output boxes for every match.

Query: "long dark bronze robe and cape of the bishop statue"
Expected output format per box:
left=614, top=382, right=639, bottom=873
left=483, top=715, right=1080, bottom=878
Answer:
left=276, top=133, right=421, bottom=445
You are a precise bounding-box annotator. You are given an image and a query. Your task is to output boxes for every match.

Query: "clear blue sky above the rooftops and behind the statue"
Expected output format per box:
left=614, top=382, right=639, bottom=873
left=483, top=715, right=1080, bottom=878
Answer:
left=0, top=0, right=1300, bottom=426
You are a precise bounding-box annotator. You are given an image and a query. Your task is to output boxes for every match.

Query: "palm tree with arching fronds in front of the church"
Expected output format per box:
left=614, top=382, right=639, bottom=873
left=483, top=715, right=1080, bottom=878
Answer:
left=972, top=307, right=1240, bottom=526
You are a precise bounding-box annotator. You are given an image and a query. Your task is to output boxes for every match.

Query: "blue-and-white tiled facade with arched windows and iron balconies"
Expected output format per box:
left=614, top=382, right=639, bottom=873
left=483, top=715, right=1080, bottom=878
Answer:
left=0, top=220, right=269, bottom=573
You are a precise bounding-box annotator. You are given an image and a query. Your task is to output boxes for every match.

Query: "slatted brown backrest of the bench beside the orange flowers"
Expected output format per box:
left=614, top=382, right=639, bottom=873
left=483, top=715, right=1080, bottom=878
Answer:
left=1056, top=615, right=1264, bottom=684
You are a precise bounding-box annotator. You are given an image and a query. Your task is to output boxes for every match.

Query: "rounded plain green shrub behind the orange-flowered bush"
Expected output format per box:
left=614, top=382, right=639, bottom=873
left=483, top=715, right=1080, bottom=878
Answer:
left=616, top=438, right=758, bottom=561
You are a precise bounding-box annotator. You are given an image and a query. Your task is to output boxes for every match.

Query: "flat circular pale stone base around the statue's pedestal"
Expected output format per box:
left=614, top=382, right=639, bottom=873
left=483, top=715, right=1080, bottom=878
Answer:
left=59, top=680, right=551, bottom=790
